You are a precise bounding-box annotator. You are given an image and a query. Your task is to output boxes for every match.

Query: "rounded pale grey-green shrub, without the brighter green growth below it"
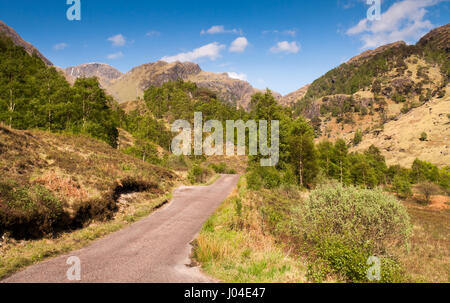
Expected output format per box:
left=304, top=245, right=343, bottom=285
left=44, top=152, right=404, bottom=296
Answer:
left=302, top=184, right=411, bottom=253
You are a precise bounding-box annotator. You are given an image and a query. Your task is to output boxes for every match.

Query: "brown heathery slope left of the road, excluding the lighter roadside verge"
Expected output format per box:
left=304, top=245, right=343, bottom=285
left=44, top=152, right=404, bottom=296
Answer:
left=0, top=125, right=177, bottom=238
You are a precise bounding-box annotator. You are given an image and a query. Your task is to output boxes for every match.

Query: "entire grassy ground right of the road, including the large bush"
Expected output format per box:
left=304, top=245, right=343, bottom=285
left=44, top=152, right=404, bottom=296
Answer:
left=194, top=177, right=450, bottom=283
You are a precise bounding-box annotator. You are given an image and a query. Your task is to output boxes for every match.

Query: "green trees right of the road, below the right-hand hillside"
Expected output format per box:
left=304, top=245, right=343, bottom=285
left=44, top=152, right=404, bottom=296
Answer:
left=243, top=91, right=450, bottom=197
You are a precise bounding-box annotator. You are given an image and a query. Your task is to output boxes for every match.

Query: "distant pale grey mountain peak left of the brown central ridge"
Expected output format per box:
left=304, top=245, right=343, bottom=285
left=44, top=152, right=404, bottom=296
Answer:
left=64, top=63, right=122, bottom=87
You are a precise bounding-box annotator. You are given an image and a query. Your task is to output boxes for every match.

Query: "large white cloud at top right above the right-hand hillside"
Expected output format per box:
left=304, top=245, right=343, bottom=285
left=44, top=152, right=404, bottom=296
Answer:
left=347, top=0, right=441, bottom=49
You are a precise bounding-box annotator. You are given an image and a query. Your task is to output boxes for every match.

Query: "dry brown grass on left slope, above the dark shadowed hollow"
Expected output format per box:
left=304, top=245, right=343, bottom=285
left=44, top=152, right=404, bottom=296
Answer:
left=0, top=127, right=178, bottom=210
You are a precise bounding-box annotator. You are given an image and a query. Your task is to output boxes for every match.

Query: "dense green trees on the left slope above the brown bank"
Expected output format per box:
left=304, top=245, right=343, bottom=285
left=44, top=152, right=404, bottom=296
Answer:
left=0, top=36, right=118, bottom=146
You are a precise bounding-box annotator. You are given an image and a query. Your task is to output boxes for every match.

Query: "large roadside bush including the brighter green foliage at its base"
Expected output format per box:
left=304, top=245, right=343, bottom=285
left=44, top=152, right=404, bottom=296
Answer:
left=299, top=184, right=411, bottom=282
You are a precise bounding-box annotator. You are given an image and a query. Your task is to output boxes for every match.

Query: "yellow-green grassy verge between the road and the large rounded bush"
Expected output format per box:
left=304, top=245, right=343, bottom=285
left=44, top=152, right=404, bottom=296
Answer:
left=194, top=178, right=306, bottom=283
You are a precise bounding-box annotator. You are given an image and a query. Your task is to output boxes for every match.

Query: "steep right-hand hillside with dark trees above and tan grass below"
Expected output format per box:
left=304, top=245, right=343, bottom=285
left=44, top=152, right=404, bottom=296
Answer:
left=284, top=24, right=450, bottom=166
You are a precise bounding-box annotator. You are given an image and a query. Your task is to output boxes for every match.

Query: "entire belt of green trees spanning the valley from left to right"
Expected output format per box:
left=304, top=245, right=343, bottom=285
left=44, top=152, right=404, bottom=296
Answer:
left=0, top=32, right=450, bottom=197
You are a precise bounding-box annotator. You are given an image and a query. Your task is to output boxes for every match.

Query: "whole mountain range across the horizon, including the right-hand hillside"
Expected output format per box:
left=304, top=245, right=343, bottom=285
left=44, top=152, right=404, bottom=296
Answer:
left=0, top=21, right=450, bottom=166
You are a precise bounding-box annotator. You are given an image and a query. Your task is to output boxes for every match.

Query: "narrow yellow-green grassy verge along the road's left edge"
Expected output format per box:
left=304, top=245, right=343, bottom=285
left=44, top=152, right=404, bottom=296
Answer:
left=0, top=193, right=171, bottom=279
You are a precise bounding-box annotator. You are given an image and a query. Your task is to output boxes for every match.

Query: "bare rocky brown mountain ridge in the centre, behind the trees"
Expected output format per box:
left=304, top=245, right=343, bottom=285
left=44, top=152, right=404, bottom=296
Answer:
left=106, top=61, right=281, bottom=108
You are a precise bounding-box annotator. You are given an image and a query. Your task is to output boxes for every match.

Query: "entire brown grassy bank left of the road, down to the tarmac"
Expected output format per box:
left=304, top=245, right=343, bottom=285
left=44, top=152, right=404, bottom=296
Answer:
left=0, top=126, right=181, bottom=278
